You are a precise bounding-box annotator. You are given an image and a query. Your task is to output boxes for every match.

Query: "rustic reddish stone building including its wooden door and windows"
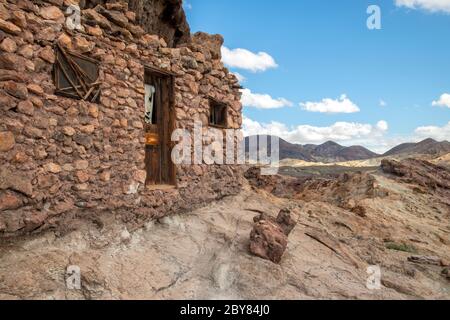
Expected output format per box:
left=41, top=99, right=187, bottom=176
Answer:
left=0, top=0, right=242, bottom=236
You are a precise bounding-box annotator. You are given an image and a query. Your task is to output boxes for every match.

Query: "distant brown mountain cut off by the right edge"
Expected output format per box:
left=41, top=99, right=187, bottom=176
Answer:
left=383, top=139, right=450, bottom=156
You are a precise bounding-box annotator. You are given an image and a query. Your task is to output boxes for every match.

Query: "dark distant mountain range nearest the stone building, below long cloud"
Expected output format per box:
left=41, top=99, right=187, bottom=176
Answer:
left=245, top=136, right=379, bottom=162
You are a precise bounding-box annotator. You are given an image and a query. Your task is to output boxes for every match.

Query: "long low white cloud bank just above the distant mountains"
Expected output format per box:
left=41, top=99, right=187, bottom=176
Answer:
left=243, top=117, right=388, bottom=145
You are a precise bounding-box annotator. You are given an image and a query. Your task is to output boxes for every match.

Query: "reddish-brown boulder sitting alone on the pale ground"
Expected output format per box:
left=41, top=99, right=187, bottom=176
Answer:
left=250, top=209, right=297, bottom=263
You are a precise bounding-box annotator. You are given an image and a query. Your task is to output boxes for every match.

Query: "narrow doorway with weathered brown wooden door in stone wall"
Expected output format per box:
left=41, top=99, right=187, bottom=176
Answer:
left=144, top=67, right=175, bottom=187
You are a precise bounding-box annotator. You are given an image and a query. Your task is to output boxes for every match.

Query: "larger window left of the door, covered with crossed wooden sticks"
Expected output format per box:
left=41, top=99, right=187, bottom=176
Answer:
left=54, top=45, right=101, bottom=102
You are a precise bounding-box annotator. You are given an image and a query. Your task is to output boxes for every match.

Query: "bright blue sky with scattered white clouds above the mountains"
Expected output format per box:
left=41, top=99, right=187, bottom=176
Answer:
left=185, top=0, right=450, bottom=152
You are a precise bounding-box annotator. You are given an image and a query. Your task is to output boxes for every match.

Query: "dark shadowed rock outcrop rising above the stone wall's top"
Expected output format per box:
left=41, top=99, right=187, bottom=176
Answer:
left=80, top=0, right=190, bottom=47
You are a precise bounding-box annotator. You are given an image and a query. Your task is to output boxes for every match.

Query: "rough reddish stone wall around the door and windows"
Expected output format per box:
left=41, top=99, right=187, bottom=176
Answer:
left=0, top=0, right=242, bottom=236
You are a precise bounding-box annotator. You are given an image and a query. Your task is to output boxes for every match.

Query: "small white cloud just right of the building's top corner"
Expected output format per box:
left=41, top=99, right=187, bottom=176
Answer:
left=222, top=47, right=278, bottom=72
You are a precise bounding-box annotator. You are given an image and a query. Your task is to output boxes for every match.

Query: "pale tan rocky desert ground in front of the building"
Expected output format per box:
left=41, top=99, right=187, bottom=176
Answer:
left=0, top=155, right=450, bottom=300
